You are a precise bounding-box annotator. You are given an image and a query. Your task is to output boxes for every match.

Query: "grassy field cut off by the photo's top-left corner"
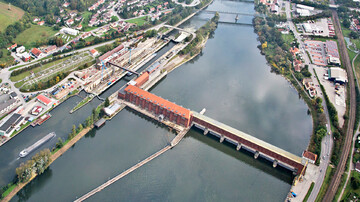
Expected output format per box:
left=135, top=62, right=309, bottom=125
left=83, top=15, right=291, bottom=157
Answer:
left=0, top=1, right=24, bottom=32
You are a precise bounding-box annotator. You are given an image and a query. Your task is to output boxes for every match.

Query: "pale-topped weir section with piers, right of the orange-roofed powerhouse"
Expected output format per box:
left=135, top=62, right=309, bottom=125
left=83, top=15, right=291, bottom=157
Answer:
left=192, top=111, right=306, bottom=175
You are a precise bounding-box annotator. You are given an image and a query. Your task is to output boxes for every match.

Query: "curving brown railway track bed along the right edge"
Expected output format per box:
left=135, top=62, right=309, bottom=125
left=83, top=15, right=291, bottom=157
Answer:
left=323, top=7, right=356, bottom=201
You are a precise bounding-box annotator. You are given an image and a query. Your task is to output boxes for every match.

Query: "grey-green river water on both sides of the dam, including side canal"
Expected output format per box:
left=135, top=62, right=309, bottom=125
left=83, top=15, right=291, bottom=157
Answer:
left=8, top=0, right=312, bottom=201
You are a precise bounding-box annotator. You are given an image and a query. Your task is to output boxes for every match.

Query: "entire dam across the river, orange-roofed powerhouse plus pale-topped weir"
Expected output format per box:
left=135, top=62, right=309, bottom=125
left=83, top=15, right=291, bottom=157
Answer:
left=118, top=85, right=306, bottom=175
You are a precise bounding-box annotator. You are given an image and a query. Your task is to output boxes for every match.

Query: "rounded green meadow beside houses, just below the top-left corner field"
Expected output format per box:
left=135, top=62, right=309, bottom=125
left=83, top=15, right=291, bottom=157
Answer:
left=15, top=25, right=57, bottom=49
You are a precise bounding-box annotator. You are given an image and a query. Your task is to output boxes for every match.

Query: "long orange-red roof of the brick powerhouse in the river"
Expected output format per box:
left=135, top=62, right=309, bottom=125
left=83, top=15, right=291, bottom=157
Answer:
left=125, top=85, right=191, bottom=119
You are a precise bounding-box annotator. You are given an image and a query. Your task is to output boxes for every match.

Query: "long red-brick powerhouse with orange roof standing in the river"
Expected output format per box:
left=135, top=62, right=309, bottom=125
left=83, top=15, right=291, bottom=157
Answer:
left=119, top=85, right=191, bottom=127
